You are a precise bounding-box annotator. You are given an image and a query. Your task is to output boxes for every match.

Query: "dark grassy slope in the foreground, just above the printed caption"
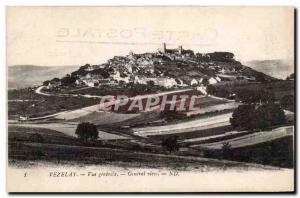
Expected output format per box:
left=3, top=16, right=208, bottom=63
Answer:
left=8, top=126, right=276, bottom=171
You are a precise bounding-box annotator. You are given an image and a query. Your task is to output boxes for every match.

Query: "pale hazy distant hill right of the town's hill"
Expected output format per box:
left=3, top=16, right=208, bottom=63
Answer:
left=245, top=59, right=294, bottom=79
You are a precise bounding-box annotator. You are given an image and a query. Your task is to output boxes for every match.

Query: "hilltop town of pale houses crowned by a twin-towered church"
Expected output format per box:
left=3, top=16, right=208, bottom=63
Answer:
left=44, top=43, right=274, bottom=92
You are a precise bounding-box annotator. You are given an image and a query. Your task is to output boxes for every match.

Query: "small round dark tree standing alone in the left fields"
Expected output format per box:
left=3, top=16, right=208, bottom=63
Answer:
left=75, top=122, right=99, bottom=142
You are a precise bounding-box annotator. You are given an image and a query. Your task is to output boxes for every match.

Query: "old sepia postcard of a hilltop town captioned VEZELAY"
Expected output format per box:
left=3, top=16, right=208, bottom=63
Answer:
left=6, top=6, right=296, bottom=192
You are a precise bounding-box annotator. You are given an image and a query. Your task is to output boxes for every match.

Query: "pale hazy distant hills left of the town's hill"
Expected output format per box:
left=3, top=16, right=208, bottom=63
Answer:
left=7, top=65, right=78, bottom=89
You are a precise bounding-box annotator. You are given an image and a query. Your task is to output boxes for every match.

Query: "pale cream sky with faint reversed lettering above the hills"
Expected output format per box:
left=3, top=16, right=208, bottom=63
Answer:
left=6, top=7, right=294, bottom=66
